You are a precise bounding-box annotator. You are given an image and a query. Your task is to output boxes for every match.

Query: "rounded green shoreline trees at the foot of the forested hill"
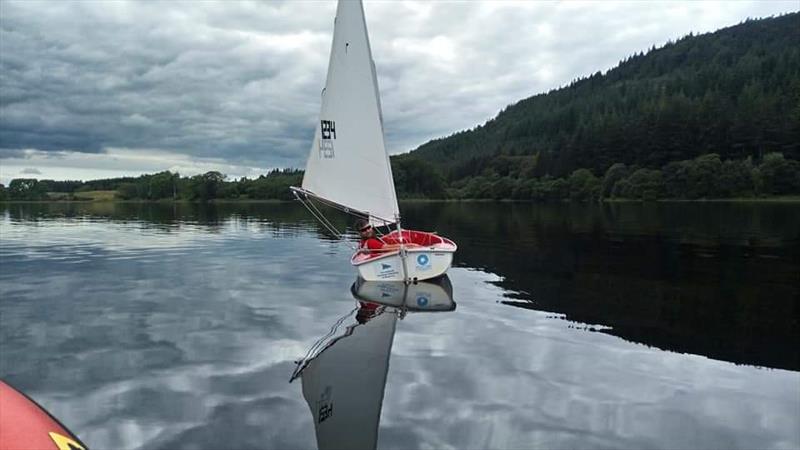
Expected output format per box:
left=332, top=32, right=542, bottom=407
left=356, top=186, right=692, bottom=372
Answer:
left=445, top=153, right=800, bottom=201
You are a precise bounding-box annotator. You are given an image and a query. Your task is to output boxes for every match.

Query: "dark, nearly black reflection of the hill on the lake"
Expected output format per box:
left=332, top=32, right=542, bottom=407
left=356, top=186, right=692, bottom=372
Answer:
left=405, top=203, right=800, bottom=370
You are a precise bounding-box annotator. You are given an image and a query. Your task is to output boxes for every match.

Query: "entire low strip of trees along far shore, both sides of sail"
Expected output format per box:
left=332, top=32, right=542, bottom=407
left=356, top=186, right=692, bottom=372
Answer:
left=0, top=152, right=800, bottom=201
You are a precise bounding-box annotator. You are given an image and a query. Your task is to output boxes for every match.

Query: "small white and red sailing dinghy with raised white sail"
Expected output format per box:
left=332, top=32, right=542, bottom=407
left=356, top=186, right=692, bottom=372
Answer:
left=291, top=0, right=457, bottom=282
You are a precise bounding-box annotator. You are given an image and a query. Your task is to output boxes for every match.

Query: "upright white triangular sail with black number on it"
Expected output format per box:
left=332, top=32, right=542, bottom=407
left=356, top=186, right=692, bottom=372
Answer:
left=303, top=0, right=399, bottom=225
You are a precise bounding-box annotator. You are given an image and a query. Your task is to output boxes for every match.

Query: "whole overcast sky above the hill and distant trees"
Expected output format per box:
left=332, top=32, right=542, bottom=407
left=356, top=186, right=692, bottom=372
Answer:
left=0, top=0, right=798, bottom=184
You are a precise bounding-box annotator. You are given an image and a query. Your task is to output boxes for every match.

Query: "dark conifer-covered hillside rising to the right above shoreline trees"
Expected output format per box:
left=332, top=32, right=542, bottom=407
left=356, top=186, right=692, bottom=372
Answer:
left=400, top=13, right=800, bottom=179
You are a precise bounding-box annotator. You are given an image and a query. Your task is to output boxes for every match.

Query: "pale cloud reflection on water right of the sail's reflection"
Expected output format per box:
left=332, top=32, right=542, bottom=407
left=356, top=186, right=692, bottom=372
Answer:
left=381, top=270, right=800, bottom=448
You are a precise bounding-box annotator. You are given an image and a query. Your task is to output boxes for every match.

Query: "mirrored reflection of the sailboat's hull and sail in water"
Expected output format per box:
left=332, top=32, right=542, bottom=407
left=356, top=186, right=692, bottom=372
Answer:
left=292, top=276, right=456, bottom=450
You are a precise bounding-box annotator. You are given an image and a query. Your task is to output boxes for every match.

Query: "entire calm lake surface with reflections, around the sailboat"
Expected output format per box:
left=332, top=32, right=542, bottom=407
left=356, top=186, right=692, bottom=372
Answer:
left=0, top=203, right=800, bottom=449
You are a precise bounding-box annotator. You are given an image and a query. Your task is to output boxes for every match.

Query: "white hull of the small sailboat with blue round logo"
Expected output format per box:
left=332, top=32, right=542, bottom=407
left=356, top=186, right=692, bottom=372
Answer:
left=354, top=248, right=455, bottom=281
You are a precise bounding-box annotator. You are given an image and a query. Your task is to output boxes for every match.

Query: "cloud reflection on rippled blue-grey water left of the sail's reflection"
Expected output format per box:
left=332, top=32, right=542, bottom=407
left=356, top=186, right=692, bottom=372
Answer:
left=0, top=224, right=360, bottom=448
